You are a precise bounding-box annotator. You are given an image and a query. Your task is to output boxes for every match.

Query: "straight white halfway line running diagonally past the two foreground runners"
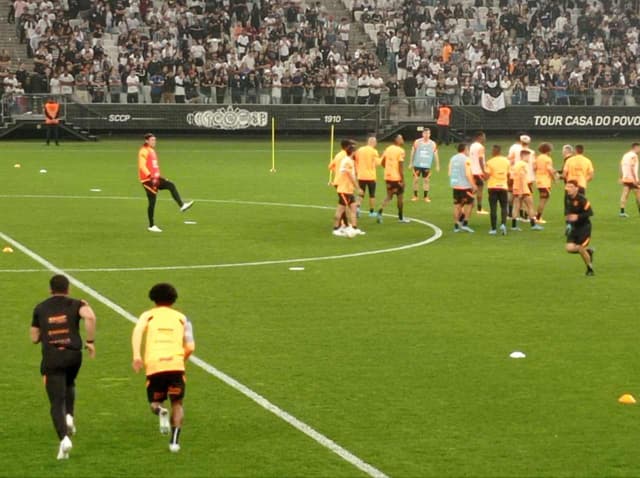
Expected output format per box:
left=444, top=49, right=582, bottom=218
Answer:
left=0, top=232, right=387, bottom=478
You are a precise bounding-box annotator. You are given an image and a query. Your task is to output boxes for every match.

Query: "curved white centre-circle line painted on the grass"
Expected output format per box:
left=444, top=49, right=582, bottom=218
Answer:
left=0, top=194, right=442, bottom=273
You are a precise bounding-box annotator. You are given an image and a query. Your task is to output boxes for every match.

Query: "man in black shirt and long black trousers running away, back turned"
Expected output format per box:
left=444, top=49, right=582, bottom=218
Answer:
left=31, top=275, right=96, bottom=460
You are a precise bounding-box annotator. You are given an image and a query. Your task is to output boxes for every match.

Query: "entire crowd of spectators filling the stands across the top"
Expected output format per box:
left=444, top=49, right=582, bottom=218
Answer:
left=0, top=0, right=640, bottom=109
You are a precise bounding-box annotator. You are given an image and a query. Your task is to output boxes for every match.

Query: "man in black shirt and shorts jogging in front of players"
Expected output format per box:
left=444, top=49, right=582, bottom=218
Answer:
left=564, top=180, right=594, bottom=276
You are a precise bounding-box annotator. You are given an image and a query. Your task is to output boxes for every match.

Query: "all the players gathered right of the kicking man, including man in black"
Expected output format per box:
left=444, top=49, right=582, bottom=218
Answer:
left=329, top=127, right=612, bottom=275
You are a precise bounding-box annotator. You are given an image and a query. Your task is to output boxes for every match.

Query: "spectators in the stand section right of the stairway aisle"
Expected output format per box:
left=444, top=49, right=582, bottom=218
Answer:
left=370, top=0, right=640, bottom=109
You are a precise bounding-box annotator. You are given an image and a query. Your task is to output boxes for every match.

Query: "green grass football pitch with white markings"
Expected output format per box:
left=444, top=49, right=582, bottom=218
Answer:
left=0, top=135, right=640, bottom=477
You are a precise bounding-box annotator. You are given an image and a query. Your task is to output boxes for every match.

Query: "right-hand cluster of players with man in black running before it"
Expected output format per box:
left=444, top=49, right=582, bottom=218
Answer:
left=449, top=132, right=596, bottom=276
